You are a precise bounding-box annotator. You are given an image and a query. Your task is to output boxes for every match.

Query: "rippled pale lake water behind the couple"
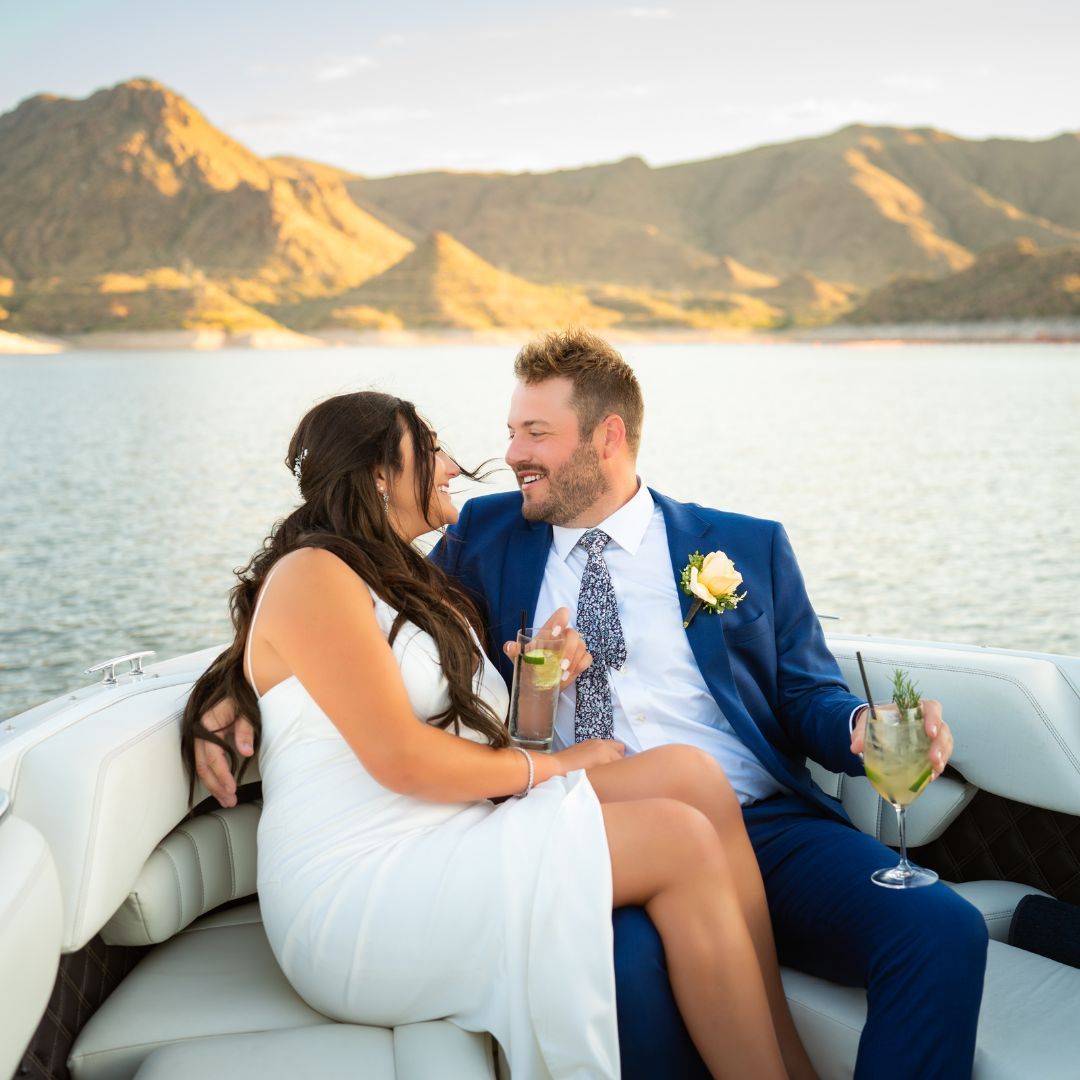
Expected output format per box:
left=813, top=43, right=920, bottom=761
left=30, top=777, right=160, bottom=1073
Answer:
left=0, top=345, right=1080, bottom=717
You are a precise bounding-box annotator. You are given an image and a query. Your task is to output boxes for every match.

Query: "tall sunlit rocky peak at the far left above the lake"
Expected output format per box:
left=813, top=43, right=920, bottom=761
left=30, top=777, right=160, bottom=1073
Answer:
left=0, top=79, right=413, bottom=298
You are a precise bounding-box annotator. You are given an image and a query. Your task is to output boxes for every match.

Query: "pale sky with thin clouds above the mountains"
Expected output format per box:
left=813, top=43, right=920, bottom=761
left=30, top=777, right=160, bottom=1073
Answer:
left=0, top=0, right=1080, bottom=176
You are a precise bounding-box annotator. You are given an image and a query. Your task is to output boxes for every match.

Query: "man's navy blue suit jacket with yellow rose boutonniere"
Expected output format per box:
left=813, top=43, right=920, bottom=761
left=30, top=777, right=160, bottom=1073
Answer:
left=431, top=488, right=862, bottom=821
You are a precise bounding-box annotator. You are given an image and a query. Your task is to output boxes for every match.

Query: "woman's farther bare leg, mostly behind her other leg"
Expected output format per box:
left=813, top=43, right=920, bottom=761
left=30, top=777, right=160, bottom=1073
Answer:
left=589, top=746, right=816, bottom=1080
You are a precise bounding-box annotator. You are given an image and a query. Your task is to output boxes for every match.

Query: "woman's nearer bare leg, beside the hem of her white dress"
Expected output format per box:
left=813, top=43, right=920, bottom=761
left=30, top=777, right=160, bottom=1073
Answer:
left=603, top=799, right=787, bottom=1080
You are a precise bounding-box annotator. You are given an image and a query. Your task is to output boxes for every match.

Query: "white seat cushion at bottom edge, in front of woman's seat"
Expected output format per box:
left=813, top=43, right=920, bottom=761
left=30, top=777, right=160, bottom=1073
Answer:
left=136, top=1023, right=495, bottom=1080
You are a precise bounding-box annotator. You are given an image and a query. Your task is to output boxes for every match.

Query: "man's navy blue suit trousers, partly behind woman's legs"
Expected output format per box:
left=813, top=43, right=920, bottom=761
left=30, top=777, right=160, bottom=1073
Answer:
left=613, top=795, right=987, bottom=1080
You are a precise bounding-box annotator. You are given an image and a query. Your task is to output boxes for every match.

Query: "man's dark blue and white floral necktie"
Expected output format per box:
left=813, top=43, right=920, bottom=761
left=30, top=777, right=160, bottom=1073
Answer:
left=573, top=529, right=626, bottom=742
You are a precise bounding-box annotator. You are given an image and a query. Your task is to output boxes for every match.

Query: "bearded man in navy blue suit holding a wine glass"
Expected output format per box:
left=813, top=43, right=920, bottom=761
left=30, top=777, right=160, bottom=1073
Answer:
left=432, top=330, right=987, bottom=1078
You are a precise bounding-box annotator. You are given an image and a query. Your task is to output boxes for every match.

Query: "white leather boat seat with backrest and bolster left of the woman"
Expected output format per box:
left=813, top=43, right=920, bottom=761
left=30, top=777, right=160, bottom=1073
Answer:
left=0, top=673, right=494, bottom=1080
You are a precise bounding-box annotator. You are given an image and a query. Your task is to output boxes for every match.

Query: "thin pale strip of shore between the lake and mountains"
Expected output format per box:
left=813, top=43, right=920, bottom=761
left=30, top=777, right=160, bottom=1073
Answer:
left=0, top=319, right=1080, bottom=356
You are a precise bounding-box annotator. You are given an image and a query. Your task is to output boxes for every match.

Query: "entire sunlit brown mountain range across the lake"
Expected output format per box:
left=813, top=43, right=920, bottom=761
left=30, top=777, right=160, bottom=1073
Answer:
left=0, top=79, right=1080, bottom=335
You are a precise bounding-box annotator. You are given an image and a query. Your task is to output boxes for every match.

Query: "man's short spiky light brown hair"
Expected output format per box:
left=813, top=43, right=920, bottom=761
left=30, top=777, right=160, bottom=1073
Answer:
left=514, top=326, right=645, bottom=454
